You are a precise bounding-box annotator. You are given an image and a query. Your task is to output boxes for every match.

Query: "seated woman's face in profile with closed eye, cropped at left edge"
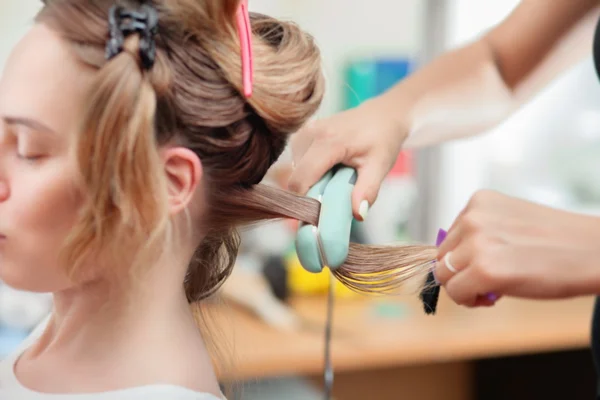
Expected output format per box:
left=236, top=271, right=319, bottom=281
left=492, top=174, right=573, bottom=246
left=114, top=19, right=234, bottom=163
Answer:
left=0, top=25, right=92, bottom=292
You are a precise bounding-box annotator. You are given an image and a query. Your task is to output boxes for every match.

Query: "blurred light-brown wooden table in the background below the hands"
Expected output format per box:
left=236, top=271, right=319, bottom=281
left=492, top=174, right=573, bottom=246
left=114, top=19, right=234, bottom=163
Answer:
left=211, top=294, right=593, bottom=400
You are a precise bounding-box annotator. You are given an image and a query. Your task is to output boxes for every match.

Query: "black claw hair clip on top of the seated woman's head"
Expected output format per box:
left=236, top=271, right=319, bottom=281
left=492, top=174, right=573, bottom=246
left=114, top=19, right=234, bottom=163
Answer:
left=106, top=4, right=158, bottom=70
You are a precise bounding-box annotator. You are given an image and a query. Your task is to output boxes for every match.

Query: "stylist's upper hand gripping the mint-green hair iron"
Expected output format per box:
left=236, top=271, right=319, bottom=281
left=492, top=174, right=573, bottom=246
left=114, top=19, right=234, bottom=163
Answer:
left=288, top=96, right=407, bottom=220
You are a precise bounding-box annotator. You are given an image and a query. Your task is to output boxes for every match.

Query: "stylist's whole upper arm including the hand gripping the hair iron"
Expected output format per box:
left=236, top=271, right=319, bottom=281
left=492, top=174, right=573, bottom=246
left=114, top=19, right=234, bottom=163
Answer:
left=289, top=0, right=599, bottom=220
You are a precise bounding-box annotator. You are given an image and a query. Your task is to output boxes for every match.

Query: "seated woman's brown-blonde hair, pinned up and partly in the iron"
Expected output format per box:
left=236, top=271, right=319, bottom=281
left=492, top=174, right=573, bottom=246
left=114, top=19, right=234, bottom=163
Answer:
left=38, top=0, right=436, bottom=312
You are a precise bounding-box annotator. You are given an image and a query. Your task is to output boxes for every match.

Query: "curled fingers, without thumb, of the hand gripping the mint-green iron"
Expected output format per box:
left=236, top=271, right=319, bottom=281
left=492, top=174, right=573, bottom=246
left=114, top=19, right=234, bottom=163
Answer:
left=288, top=135, right=350, bottom=195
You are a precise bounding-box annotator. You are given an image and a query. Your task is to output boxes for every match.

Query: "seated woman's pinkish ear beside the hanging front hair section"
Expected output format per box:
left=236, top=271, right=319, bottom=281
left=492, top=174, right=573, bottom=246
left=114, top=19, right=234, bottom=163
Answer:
left=161, top=147, right=202, bottom=215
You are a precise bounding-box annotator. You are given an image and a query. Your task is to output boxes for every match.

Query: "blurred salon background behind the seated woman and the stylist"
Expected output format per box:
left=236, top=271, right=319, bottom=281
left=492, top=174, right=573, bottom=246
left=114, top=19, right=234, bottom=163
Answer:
left=0, top=0, right=600, bottom=400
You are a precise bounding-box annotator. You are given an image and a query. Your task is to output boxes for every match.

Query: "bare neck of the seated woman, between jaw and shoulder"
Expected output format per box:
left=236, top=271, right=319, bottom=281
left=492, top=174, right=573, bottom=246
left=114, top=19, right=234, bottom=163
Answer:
left=45, top=222, right=197, bottom=346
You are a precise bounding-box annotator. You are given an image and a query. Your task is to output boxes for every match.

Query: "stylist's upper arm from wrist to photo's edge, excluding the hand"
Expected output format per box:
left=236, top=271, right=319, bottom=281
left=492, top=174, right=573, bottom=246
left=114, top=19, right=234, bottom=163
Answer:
left=381, top=0, right=600, bottom=148
